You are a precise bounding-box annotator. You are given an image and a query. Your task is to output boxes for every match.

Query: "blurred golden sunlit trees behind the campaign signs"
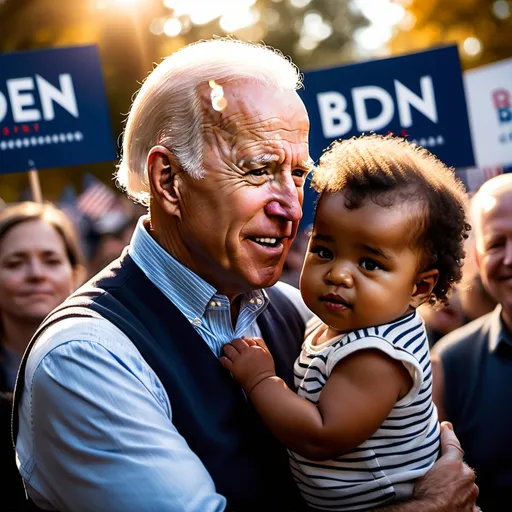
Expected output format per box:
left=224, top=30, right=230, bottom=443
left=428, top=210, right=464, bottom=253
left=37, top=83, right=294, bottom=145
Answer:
left=0, top=0, right=512, bottom=202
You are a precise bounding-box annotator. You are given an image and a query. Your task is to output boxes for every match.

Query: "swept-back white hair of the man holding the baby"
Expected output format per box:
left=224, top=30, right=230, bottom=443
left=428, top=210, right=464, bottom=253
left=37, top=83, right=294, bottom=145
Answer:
left=116, top=38, right=302, bottom=206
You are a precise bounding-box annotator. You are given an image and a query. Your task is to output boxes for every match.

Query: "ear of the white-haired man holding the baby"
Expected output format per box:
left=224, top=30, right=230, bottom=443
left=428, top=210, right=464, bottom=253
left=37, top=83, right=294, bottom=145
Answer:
left=147, top=146, right=182, bottom=217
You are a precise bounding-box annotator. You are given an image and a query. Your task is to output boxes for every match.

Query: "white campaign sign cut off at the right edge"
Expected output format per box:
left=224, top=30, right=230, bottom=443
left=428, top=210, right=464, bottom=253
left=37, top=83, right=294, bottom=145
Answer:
left=464, top=59, right=512, bottom=167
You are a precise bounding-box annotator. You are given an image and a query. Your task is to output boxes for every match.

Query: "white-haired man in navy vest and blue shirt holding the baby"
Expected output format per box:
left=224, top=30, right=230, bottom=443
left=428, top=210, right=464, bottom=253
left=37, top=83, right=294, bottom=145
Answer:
left=14, top=40, right=477, bottom=512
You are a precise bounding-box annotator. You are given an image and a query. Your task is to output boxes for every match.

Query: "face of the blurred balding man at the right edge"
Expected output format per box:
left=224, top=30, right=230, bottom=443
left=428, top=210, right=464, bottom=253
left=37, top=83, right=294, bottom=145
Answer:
left=475, top=187, right=512, bottom=325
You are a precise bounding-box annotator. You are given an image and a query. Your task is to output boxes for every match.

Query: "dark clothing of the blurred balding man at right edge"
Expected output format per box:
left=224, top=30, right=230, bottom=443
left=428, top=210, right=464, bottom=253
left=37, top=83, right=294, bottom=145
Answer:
left=435, top=307, right=512, bottom=512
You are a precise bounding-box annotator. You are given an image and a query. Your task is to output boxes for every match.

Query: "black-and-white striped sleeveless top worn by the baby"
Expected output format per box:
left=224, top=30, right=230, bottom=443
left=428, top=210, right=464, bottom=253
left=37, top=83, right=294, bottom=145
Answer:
left=289, top=312, right=440, bottom=511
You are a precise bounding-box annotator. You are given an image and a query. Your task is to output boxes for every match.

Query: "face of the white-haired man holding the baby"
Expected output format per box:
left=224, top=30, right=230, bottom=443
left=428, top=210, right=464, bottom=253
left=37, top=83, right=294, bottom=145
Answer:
left=172, top=81, right=310, bottom=296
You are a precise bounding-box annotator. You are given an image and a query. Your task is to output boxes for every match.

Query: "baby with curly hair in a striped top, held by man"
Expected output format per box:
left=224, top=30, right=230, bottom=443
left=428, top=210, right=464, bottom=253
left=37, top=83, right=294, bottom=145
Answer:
left=221, top=135, right=470, bottom=511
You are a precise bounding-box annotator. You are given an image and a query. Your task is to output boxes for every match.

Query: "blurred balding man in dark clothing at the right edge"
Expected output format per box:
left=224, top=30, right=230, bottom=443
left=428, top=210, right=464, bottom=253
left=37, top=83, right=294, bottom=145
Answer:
left=432, top=174, right=512, bottom=512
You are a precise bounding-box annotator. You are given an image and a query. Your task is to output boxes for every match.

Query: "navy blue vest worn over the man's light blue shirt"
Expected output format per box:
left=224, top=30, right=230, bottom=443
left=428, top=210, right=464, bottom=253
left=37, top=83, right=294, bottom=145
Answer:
left=13, top=254, right=305, bottom=512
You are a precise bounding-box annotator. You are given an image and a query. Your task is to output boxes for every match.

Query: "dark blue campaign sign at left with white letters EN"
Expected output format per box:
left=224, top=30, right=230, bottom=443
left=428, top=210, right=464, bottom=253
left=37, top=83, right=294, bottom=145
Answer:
left=0, top=46, right=116, bottom=174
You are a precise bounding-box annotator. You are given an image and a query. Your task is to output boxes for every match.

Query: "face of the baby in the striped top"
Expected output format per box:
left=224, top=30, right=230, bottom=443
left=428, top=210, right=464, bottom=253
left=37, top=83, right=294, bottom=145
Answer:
left=300, top=193, right=422, bottom=332
